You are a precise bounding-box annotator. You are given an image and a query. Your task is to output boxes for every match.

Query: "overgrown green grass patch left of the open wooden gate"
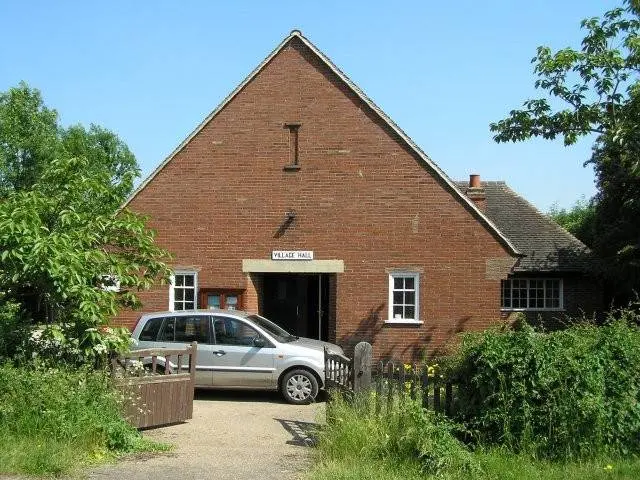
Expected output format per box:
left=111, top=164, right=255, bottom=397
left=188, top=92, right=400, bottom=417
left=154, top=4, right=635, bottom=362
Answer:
left=0, top=365, right=168, bottom=475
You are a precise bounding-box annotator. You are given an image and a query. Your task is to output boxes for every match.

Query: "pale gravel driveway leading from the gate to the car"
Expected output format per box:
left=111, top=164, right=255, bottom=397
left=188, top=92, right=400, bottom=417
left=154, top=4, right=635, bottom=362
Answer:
left=88, top=391, right=324, bottom=480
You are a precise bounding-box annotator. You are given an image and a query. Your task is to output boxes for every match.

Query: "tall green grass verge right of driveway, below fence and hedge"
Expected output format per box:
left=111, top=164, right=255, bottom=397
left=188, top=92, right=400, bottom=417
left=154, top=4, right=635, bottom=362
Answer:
left=307, top=396, right=640, bottom=480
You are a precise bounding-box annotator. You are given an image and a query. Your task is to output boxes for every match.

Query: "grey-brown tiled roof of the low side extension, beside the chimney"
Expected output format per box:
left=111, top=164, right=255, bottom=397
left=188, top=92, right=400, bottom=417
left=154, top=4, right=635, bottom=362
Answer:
left=457, top=182, right=593, bottom=272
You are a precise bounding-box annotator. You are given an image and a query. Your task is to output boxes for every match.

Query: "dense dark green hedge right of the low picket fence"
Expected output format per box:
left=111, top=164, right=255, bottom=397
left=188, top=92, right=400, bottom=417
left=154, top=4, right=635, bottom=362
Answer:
left=451, top=310, right=640, bottom=459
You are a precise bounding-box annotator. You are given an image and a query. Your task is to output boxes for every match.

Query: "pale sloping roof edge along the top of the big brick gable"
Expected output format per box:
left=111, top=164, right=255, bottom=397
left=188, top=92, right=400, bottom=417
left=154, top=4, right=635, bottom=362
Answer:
left=120, top=30, right=521, bottom=256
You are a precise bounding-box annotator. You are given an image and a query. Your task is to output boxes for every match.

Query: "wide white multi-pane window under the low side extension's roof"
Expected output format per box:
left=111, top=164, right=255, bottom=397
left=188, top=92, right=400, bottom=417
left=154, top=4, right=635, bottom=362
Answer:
left=500, top=278, right=564, bottom=310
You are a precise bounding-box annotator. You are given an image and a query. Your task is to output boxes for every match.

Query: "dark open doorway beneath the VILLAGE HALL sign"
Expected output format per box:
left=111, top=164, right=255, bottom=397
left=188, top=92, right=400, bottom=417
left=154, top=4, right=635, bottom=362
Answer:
left=260, top=273, right=329, bottom=341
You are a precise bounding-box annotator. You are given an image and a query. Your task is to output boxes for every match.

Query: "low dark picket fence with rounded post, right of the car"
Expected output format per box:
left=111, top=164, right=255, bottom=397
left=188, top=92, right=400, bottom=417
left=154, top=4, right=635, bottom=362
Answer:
left=325, top=342, right=457, bottom=415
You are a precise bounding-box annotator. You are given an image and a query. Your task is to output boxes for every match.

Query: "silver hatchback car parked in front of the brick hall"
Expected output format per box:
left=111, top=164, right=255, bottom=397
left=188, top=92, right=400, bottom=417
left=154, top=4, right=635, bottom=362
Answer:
left=132, top=310, right=343, bottom=404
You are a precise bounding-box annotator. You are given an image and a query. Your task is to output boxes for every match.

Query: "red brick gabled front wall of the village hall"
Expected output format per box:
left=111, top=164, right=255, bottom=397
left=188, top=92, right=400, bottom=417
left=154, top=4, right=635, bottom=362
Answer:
left=117, top=39, right=509, bottom=359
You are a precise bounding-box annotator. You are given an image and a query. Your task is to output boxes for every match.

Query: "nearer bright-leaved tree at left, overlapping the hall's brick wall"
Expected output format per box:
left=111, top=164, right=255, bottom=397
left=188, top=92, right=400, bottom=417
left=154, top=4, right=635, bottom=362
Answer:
left=0, top=157, right=170, bottom=357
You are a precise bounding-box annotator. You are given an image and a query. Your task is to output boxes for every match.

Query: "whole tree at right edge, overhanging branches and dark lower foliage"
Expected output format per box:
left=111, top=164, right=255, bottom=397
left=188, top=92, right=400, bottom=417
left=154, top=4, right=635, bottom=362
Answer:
left=490, top=0, right=640, bottom=301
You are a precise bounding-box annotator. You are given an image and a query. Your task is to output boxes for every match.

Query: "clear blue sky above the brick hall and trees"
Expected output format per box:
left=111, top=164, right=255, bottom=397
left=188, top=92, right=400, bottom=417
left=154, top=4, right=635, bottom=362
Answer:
left=0, top=0, right=621, bottom=211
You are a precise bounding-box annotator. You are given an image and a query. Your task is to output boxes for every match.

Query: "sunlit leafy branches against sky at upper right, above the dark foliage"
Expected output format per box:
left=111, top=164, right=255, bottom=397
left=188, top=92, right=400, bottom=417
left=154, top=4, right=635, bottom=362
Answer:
left=490, top=2, right=640, bottom=145
